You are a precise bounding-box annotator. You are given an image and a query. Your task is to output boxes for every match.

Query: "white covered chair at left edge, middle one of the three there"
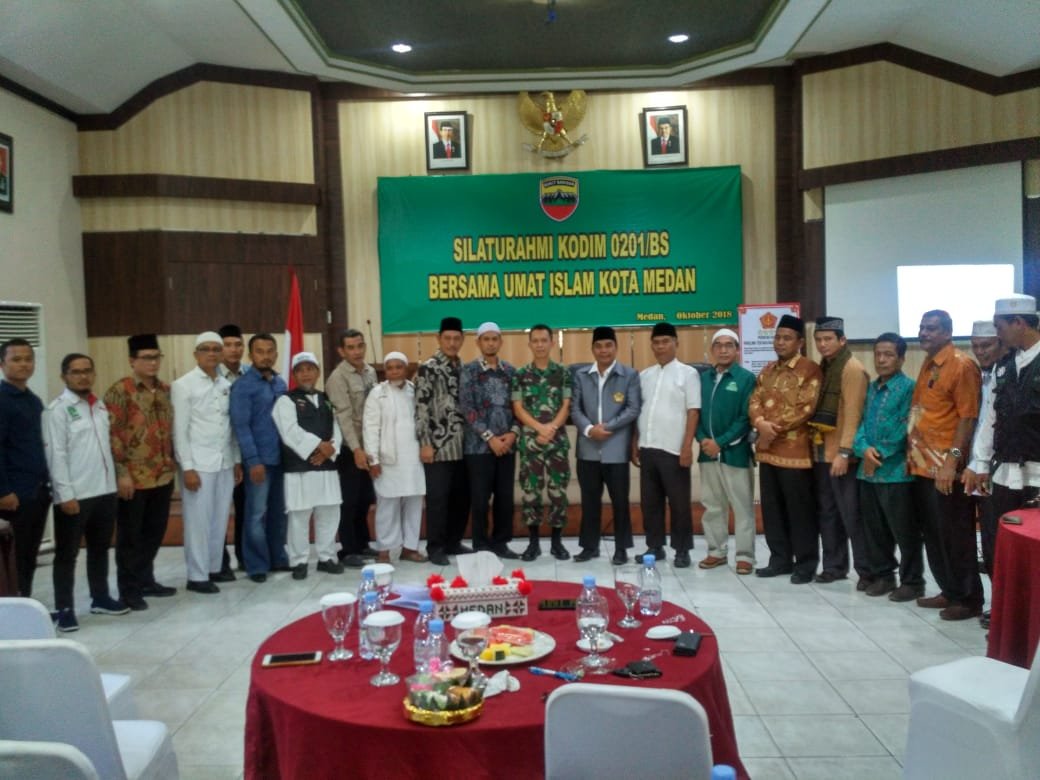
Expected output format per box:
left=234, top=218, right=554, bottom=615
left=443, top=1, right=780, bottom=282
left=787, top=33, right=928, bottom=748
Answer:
left=0, top=640, right=178, bottom=780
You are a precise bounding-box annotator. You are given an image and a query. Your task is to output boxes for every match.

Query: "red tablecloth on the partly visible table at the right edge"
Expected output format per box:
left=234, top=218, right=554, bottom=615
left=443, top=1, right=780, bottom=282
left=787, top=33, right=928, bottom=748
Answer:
left=986, top=510, right=1040, bottom=669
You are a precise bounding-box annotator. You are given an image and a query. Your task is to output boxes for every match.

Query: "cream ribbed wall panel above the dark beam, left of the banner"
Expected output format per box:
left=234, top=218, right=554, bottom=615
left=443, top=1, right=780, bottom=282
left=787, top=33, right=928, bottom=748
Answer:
left=79, top=81, right=314, bottom=183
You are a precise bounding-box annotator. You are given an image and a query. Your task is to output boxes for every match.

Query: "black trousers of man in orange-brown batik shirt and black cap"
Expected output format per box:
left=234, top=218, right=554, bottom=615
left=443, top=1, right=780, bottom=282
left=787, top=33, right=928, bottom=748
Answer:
left=758, top=463, right=820, bottom=577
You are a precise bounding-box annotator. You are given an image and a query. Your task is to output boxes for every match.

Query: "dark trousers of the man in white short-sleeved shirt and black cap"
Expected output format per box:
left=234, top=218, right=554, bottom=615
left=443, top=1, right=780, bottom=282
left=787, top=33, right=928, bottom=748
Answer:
left=636, top=447, right=694, bottom=552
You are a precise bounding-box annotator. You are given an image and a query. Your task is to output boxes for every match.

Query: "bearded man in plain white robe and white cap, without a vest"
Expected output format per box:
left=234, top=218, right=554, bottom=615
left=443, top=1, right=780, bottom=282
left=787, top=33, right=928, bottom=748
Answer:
left=362, top=352, right=427, bottom=564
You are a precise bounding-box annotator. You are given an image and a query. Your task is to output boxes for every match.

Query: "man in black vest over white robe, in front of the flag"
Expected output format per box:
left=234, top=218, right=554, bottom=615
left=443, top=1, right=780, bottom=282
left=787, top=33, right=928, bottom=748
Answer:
left=271, top=353, right=343, bottom=579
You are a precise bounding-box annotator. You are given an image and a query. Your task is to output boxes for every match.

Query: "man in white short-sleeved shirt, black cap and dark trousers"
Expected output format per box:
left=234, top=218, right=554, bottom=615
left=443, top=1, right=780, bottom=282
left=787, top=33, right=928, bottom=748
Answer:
left=632, top=322, right=701, bottom=569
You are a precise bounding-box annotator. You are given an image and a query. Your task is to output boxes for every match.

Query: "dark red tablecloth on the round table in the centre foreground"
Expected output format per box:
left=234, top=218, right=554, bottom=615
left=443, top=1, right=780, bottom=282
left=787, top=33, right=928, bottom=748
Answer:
left=245, top=581, right=747, bottom=780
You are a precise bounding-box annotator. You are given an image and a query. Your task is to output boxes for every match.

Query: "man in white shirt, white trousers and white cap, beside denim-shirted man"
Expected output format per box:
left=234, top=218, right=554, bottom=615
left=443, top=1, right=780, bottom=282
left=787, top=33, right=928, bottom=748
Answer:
left=170, top=331, right=242, bottom=594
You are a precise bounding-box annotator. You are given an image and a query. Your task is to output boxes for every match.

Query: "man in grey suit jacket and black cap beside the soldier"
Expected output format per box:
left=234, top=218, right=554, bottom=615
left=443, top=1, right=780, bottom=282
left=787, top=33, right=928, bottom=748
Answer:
left=571, top=327, right=642, bottom=565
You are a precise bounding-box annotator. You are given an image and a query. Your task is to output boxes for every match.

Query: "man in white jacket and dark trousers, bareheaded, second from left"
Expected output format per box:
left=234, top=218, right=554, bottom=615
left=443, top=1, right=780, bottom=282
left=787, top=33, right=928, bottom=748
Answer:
left=44, top=353, right=130, bottom=631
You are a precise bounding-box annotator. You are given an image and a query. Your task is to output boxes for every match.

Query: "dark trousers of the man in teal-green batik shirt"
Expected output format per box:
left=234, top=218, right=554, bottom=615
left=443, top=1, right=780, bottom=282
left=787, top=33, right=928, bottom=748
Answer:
left=859, top=482, right=925, bottom=587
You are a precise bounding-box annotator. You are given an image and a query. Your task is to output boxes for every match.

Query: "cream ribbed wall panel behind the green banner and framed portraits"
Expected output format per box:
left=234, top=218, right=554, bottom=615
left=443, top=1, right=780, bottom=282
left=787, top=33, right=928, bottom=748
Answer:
left=339, top=85, right=776, bottom=360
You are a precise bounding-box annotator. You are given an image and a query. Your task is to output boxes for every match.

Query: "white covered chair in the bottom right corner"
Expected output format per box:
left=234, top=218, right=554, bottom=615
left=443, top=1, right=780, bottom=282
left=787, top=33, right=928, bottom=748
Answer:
left=903, top=653, right=1040, bottom=780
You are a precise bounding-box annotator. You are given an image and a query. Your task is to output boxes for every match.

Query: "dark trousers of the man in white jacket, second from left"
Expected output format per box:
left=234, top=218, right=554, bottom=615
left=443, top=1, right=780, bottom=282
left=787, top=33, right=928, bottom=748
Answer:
left=53, top=493, right=115, bottom=609
